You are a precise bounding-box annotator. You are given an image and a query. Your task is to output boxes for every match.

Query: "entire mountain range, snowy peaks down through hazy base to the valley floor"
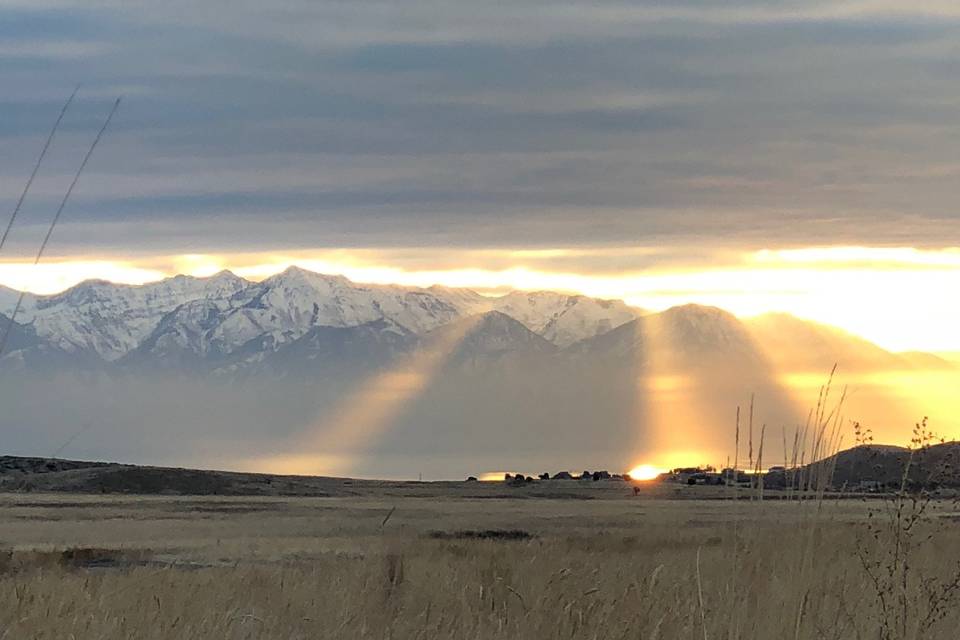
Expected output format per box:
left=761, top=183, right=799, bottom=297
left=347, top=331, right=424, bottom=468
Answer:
left=0, top=268, right=954, bottom=477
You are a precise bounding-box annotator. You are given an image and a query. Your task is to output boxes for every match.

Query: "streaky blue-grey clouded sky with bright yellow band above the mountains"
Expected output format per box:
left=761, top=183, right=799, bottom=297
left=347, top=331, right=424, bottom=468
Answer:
left=0, top=0, right=960, bottom=351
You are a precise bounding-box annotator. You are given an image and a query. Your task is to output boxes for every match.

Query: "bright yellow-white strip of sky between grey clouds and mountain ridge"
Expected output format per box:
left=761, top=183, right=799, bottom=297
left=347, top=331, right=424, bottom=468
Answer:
left=0, top=247, right=960, bottom=351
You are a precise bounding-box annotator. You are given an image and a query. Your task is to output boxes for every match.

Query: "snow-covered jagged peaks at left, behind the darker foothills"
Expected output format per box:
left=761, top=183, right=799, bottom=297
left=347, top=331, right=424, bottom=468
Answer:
left=0, top=267, right=637, bottom=366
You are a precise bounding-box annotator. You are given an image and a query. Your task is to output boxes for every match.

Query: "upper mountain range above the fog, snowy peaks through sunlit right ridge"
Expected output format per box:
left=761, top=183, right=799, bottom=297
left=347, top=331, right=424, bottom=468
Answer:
left=0, top=267, right=936, bottom=375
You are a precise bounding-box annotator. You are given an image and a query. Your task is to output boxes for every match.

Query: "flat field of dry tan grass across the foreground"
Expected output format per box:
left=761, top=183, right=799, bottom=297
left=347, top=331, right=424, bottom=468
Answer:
left=0, top=483, right=960, bottom=640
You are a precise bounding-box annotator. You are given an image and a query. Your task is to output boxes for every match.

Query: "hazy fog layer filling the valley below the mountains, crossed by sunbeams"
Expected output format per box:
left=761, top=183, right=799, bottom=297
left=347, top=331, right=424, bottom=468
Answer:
left=0, top=350, right=955, bottom=479
